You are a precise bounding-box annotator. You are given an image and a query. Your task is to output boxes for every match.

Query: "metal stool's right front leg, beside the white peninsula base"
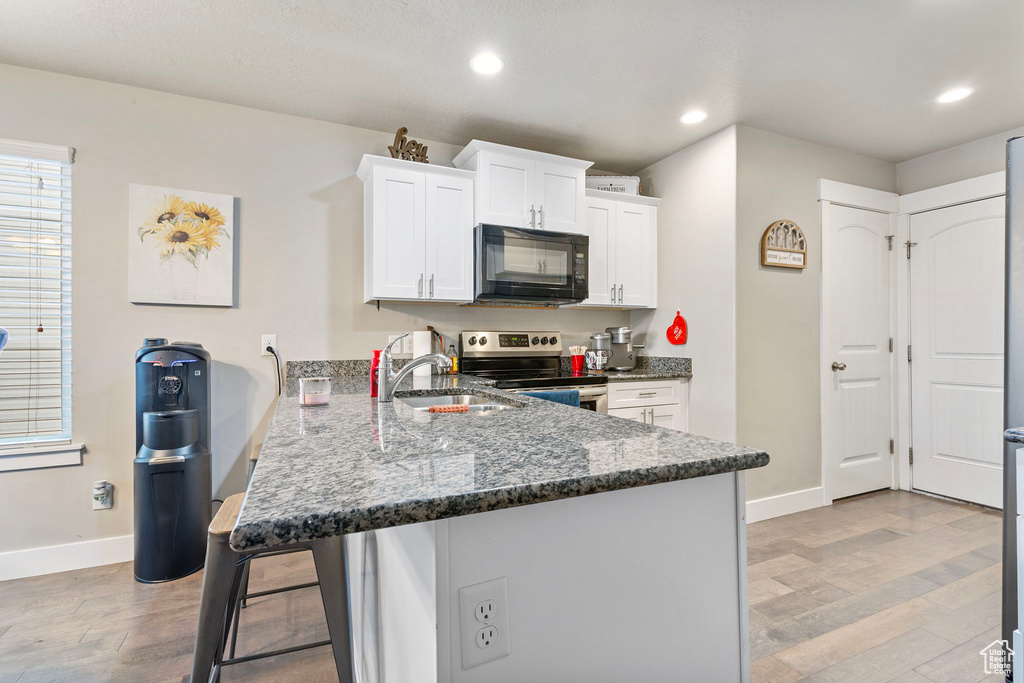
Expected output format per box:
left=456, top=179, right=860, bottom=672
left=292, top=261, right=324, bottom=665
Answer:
left=311, top=536, right=354, bottom=683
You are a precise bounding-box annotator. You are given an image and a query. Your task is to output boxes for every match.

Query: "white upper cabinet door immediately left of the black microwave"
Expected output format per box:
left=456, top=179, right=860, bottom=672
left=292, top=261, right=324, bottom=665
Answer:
left=425, top=173, right=473, bottom=301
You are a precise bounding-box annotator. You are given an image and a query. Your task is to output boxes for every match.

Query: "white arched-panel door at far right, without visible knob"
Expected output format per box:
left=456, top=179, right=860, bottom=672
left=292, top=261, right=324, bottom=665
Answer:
left=910, top=197, right=1006, bottom=508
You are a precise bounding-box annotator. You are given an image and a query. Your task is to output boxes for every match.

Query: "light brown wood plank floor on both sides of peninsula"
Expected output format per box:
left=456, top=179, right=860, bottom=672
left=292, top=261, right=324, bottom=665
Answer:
left=0, top=492, right=1000, bottom=683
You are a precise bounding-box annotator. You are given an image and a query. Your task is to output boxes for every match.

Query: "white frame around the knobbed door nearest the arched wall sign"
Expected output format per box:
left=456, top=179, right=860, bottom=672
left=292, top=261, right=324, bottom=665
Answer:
left=818, top=178, right=899, bottom=505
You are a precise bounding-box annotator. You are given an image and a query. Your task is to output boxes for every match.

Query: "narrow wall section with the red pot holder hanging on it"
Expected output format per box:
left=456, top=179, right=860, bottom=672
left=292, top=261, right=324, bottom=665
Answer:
left=632, top=126, right=736, bottom=441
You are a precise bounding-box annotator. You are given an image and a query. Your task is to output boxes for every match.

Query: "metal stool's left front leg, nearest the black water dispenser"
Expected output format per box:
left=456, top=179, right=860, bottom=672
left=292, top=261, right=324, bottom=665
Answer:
left=191, top=535, right=238, bottom=683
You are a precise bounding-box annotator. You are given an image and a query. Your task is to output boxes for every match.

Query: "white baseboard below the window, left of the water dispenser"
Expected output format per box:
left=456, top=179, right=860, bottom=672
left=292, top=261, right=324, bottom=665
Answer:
left=0, top=535, right=135, bottom=581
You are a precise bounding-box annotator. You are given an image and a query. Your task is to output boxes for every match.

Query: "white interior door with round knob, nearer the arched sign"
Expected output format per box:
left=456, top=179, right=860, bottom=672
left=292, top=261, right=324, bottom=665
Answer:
left=819, top=204, right=894, bottom=499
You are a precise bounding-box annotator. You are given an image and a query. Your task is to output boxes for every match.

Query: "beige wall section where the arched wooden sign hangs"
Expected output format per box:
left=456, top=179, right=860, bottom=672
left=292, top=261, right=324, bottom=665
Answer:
left=737, top=126, right=896, bottom=501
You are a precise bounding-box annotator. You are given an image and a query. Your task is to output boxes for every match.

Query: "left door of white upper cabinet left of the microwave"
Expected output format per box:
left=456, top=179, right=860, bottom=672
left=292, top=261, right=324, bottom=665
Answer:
left=369, top=167, right=426, bottom=299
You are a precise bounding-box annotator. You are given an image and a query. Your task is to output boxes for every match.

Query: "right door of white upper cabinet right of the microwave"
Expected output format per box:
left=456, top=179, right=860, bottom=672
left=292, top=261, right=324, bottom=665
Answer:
left=614, top=202, right=657, bottom=308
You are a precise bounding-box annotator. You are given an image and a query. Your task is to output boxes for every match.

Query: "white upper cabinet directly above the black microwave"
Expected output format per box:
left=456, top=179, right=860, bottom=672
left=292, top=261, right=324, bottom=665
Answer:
left=455, top=140, right=593, bottom=232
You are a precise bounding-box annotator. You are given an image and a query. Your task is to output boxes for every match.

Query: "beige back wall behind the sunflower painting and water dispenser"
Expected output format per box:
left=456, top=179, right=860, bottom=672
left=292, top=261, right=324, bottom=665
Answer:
left=0, top=66, right=629, bottom=551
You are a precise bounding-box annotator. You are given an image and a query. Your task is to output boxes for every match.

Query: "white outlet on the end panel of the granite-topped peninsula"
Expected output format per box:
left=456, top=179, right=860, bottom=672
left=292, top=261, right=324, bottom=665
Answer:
left=459, top=577, right=511, bottom=669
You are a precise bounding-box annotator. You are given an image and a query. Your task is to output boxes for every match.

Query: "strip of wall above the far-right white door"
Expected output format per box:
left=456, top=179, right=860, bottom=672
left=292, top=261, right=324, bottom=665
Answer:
left=896, top=122, right=1024, bottom=195
